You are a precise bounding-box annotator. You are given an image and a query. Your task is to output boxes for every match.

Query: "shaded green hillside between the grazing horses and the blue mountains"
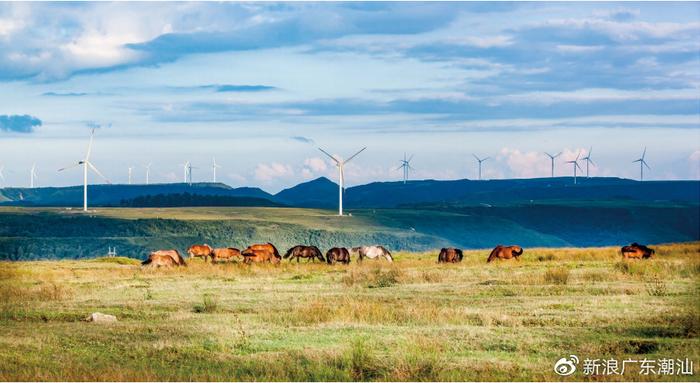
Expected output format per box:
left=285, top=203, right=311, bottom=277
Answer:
left=0, top=201, right=700, bottom=260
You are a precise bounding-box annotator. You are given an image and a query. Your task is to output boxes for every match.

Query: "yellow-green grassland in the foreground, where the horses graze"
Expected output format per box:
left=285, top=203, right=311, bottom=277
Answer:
left=0, top=243, right=700, bottom=381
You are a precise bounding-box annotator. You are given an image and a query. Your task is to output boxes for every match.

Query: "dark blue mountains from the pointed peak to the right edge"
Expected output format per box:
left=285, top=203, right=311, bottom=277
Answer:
left=275, top=177, right=700, bottom=209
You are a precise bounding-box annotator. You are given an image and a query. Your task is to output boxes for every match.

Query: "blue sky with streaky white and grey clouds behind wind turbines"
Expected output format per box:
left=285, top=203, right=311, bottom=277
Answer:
left=0, top=2, right=700, bottom=192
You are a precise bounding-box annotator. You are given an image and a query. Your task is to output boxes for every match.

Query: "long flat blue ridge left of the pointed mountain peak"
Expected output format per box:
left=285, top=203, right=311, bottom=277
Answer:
left=0, top=183, right=274, bottom=206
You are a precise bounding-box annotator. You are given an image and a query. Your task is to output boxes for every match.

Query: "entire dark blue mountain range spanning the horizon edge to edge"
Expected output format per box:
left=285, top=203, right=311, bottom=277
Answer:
left=0, top=177, right=700, bottom=209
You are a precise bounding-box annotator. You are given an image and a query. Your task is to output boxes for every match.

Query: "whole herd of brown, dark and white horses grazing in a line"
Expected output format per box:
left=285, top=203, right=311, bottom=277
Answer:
left=141, top=242, right=655, bottom=267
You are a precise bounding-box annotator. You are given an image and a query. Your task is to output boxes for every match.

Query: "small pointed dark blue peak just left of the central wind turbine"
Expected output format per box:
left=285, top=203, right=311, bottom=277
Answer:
left=275, top=177, right=338, bottom=208
